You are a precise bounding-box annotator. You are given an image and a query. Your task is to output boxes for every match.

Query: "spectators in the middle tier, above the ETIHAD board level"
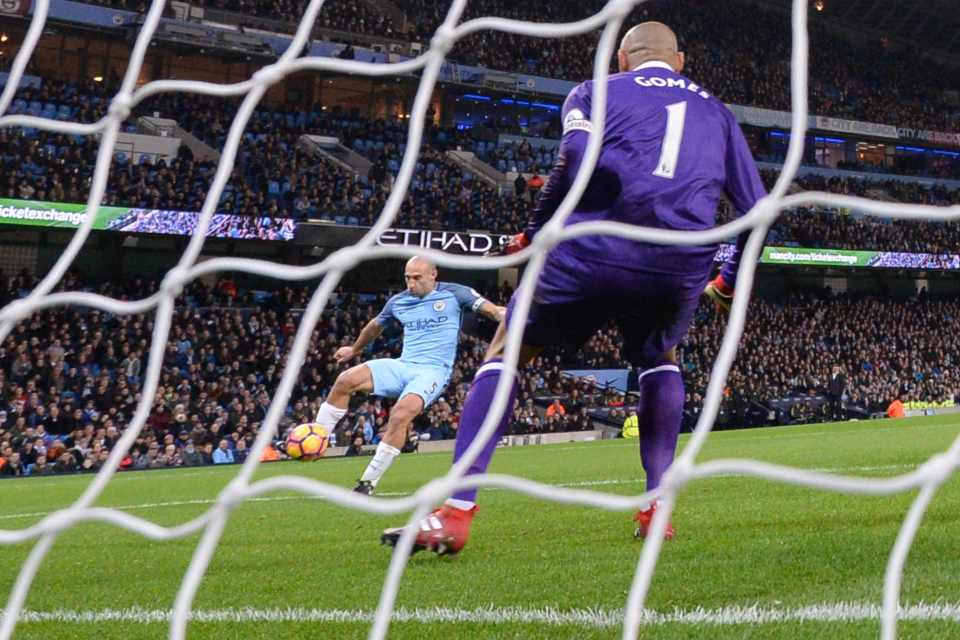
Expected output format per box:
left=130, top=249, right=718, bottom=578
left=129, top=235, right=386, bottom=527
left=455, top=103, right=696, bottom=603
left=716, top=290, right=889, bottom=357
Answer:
left=0, top=80, right=960, bottom=253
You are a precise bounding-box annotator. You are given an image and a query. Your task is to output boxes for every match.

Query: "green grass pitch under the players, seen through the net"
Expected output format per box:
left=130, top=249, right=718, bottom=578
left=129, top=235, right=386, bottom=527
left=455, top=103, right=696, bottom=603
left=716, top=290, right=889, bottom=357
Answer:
left=0, top=416, right=960, bottom=640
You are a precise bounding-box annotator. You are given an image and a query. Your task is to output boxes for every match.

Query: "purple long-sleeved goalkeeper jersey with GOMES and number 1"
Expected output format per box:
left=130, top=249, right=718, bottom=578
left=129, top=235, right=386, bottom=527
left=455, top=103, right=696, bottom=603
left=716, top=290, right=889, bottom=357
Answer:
left=527, top=61, right=766, bottom=285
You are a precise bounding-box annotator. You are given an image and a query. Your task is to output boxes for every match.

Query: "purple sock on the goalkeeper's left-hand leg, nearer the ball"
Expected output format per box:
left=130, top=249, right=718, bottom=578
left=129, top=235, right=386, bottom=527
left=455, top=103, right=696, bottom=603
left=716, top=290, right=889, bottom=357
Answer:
left=453, top=358, right=517, bottom=505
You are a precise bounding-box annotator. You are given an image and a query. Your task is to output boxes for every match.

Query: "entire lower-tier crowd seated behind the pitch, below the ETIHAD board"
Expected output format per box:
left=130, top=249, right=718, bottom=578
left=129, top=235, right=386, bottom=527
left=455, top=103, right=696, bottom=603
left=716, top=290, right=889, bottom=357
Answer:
left=0, top=264, right=960, bottom=476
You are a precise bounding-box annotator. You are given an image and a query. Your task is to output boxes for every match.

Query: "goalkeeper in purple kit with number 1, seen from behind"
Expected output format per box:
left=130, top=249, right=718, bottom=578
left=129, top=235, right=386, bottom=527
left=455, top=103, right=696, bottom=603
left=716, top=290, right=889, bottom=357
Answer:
left=382, top=22, right=766, bottom=554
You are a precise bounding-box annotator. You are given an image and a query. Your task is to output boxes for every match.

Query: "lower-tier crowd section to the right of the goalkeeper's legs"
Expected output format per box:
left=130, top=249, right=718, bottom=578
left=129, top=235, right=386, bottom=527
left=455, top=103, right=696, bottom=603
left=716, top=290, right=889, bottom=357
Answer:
left=682, top=289, right=960, bottom=426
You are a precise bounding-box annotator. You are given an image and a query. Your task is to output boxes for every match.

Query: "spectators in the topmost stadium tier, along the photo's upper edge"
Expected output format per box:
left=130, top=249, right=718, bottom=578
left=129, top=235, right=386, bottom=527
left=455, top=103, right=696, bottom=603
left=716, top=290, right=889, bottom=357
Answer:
left=65, top=0, right=960, bottom=131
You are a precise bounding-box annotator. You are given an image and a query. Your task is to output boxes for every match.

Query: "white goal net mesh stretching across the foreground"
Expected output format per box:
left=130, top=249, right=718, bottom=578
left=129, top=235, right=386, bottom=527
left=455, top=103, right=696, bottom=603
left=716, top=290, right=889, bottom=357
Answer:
left=0, top=0, right=960, bottom=640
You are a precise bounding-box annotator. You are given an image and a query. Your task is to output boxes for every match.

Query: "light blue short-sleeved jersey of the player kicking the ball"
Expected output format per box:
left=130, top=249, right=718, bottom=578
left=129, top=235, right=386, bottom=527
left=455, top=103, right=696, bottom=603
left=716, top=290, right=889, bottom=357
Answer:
left=377, top=282, right=486, bottom=368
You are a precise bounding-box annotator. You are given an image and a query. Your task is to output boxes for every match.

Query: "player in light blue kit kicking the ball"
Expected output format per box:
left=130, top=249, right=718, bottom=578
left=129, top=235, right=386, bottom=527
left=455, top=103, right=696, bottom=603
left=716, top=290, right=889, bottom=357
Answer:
left=316, top=257, right=505, bottom=495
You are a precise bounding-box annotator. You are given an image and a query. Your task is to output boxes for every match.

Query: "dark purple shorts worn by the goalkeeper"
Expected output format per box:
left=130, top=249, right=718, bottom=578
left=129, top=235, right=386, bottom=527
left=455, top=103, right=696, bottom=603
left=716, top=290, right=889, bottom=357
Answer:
left=507, top=250, right=708, bottom=369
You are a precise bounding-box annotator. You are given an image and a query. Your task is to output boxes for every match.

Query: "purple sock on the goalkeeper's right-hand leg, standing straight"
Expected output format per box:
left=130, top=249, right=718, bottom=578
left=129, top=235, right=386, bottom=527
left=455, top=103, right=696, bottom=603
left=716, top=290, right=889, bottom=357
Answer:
left=637, top=362, right=684, bottom=491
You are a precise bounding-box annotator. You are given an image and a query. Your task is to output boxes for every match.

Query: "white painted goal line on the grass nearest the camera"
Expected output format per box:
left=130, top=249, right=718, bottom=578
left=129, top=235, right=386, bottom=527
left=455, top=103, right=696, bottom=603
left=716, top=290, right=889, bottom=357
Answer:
left=0, top=602, right=960, bottom=627
